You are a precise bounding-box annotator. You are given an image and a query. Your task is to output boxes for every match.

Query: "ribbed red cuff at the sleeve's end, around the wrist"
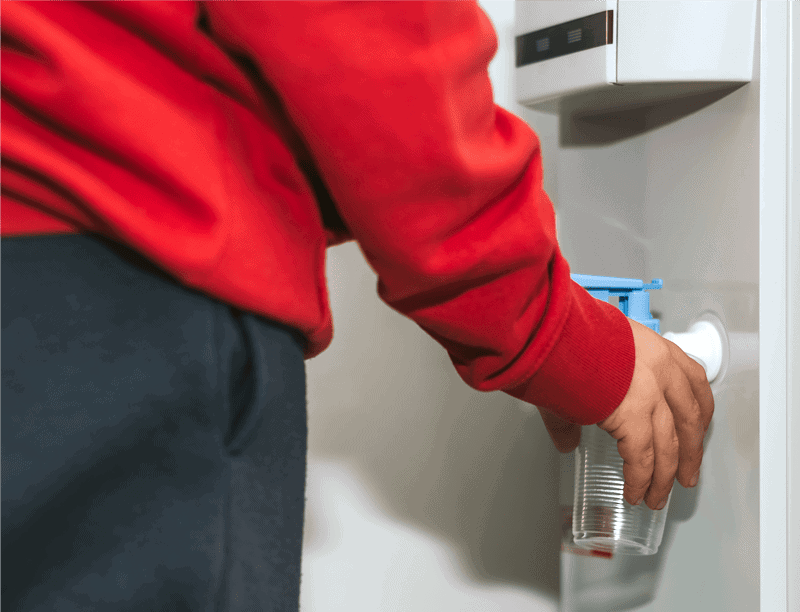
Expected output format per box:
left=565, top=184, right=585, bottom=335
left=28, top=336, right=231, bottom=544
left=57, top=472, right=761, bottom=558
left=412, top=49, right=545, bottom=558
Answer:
left=505, top=281, right=636, bottom=425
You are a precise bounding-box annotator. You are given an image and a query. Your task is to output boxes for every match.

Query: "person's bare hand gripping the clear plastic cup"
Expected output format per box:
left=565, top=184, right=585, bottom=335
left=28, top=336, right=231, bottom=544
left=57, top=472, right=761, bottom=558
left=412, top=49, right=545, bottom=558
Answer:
left=539, top=318, right=714, bottom=510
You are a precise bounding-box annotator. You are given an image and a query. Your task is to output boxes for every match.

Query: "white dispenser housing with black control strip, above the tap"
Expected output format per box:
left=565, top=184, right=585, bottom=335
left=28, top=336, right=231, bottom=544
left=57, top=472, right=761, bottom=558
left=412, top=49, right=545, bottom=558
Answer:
left=515, top=0, right=757, bottom=113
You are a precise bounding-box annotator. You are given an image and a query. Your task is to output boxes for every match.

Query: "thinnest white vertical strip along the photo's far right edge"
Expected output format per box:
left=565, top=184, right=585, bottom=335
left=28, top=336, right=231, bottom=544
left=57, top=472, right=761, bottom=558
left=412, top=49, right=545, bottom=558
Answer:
left=786, top=2, right=800, bottom=610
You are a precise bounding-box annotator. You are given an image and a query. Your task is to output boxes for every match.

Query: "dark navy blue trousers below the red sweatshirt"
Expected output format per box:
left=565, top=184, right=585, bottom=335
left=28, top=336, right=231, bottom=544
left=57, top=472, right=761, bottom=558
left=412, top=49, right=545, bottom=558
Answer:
left=0, top=235, right=307, bottom=612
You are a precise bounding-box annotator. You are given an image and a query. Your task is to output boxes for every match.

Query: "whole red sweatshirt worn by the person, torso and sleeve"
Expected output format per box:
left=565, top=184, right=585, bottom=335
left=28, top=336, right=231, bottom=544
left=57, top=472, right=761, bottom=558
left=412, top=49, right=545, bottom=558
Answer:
left=0, top=1, right=634, bottom=424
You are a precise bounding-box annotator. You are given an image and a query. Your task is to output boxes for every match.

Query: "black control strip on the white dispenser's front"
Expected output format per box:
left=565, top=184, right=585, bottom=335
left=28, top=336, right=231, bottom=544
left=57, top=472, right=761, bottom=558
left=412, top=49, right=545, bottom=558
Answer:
left=516, top=10, right=614, bottom=68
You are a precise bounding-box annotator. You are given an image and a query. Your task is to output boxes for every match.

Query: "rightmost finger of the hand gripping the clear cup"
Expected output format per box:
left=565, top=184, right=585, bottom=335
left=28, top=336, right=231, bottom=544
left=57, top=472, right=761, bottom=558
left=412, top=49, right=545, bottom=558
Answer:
left=664, top=364, right=713, bottom=488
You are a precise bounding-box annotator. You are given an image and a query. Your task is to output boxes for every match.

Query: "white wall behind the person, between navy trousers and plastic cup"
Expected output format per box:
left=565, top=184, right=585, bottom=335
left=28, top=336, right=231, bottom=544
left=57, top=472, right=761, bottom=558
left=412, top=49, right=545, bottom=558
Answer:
left=301, top=0, right=560, bottom=612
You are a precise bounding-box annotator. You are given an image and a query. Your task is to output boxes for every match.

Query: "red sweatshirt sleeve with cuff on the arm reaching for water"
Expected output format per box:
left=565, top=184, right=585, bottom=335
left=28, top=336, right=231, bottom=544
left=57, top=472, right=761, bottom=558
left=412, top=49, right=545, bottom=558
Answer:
left=203, top=1, right=634, bottom=424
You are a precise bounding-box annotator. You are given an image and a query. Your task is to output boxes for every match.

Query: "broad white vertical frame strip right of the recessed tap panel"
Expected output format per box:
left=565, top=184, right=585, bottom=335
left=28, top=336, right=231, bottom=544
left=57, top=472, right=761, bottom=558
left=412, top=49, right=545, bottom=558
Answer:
left=759, top=0, right=794, bottom=612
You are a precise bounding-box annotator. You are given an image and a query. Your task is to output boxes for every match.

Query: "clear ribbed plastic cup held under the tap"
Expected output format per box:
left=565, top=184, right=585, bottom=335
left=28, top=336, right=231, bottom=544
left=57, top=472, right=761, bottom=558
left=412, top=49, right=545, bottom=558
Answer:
left=572, top=425, right=672, bottom=555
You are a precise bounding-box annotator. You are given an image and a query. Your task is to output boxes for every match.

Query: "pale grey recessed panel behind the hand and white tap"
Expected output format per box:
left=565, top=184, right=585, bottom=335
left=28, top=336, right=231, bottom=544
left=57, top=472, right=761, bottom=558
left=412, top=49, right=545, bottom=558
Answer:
left=523, top=4, right=764, bottom=612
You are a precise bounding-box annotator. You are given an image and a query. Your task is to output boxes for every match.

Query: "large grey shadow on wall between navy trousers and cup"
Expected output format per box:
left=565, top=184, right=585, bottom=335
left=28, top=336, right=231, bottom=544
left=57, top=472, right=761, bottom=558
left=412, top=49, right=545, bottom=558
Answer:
left=307, top=245, right=561, bottom=598
